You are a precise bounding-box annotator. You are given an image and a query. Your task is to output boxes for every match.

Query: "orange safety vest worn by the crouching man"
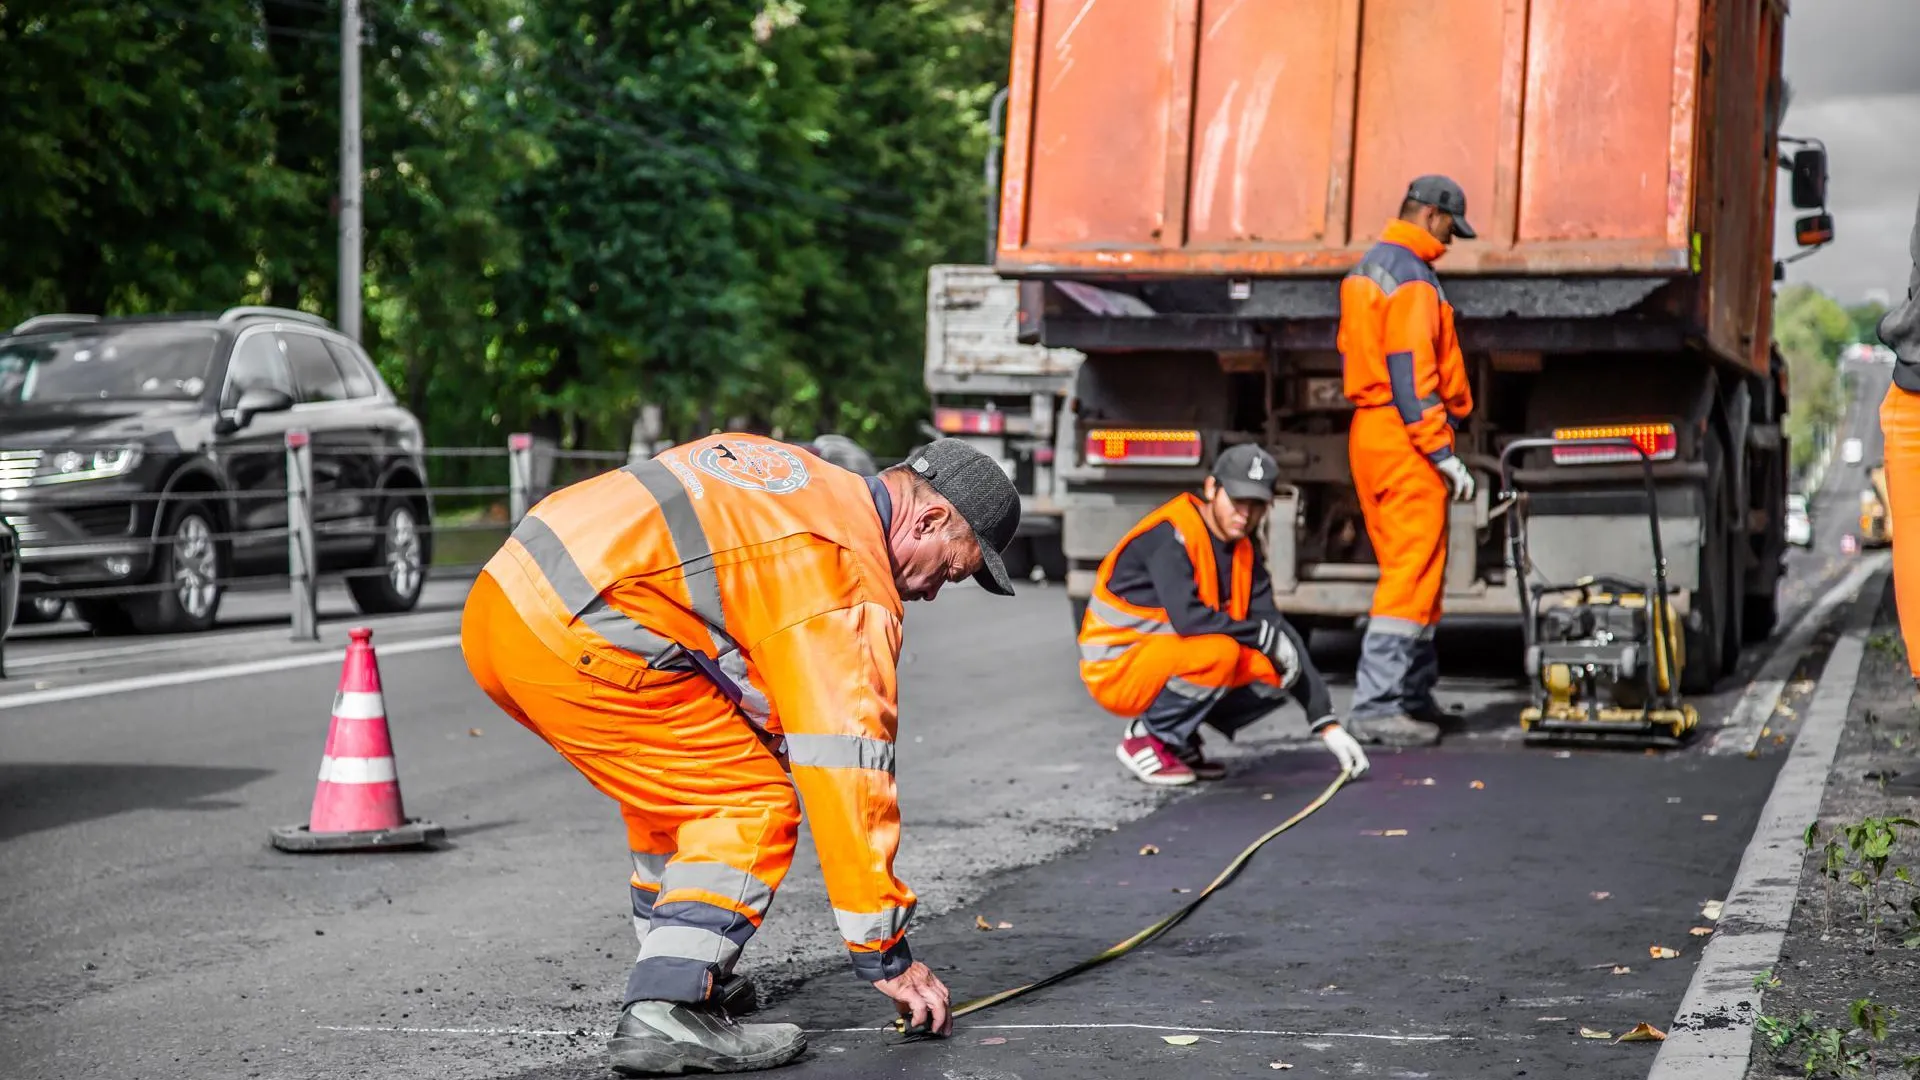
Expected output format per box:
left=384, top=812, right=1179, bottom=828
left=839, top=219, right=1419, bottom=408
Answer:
left=1079, top=492, right=1254, bottom=668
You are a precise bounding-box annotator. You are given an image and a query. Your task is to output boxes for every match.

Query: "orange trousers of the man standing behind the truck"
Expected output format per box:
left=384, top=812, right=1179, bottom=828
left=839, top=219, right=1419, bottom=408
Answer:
left=1346, top=405, right=1448, bottom=719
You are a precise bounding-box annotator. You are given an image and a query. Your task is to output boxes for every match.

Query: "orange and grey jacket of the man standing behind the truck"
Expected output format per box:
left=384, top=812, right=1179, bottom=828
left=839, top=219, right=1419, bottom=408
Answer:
left=1338, top=219, right=1473, bottom=461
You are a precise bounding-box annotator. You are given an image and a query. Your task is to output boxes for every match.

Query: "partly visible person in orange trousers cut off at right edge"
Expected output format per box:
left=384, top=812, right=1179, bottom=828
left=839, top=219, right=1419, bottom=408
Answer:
left=1876, top=187, right=1920, bottom=688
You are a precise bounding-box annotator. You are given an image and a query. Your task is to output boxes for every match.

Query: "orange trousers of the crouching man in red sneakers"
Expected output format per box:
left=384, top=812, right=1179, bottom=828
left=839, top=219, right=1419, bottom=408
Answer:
left=1081, top=634, right=1282, bottom=746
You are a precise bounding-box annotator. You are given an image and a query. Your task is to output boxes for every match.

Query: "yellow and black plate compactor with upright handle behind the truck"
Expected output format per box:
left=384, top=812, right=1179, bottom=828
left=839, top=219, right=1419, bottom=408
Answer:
left=1500, top=438, right=1699, bottom=748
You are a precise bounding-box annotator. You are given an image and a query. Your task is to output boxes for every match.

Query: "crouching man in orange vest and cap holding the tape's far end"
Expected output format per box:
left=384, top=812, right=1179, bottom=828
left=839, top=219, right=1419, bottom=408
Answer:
left=1079, top=444, right=1367, bottom=786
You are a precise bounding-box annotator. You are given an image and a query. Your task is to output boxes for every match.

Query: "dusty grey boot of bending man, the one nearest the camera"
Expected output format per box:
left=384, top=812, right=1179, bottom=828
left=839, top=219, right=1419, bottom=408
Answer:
left=607, top=1001, right=806, bottom=1076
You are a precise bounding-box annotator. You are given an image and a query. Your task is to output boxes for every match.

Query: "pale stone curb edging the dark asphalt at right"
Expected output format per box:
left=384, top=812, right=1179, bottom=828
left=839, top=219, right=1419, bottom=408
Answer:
left=1647, top=567, right=1891, bottom=1080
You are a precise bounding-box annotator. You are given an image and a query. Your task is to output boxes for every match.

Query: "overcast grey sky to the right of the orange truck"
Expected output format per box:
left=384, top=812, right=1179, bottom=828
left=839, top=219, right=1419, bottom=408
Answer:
left=1774, top=0, right=1920, bottom=304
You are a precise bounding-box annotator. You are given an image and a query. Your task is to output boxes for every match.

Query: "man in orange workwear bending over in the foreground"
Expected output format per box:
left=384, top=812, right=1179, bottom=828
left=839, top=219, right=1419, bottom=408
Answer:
left=461, top=434, right=1020, bottom=1074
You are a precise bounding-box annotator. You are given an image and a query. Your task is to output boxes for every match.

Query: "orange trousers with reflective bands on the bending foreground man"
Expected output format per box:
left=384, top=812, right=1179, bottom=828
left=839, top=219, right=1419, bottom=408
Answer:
left=461, top=573, right=801, bottom=1003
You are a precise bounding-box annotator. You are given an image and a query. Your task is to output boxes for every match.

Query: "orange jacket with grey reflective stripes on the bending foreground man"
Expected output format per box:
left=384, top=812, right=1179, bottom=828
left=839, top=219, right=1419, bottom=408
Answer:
left=486, top=434, right=914, bottom=953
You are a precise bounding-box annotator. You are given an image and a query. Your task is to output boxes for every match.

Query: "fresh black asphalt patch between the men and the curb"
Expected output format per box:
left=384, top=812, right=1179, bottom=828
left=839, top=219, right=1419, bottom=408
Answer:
left=756, top=748, right=1778, bottom=1080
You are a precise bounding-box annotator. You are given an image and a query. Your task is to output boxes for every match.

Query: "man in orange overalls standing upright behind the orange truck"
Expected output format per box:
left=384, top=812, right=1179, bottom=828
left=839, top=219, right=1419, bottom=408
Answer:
left=1338, top=177, right=1475, bottom=746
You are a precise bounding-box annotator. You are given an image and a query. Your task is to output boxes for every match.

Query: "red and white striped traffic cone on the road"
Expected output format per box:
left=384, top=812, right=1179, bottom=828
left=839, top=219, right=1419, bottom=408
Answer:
left=273, top=626, right=445, bottom=851
